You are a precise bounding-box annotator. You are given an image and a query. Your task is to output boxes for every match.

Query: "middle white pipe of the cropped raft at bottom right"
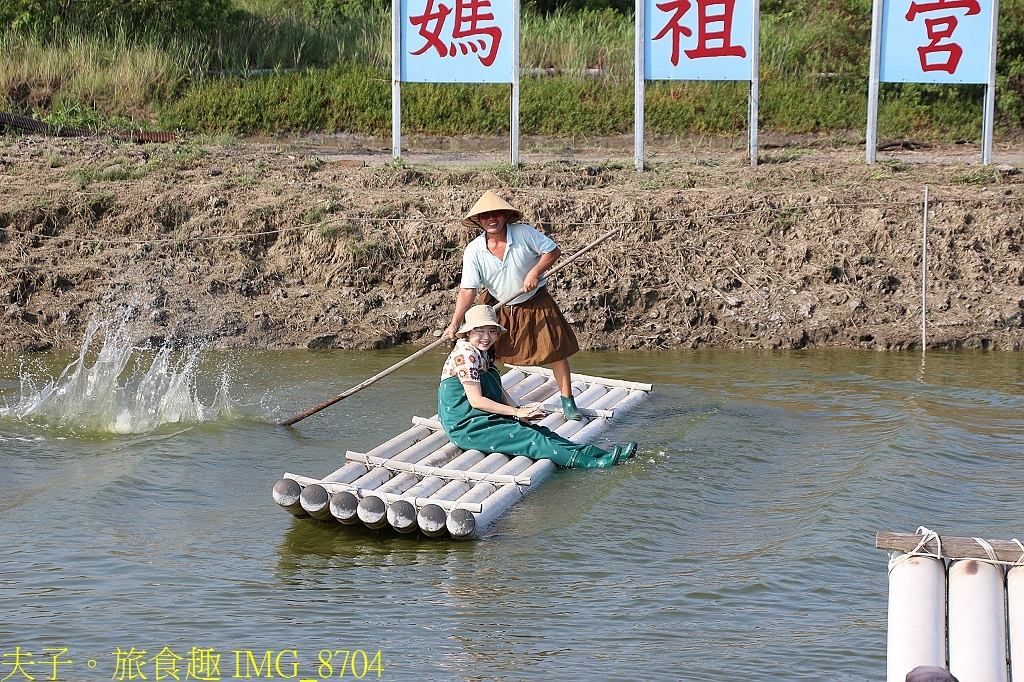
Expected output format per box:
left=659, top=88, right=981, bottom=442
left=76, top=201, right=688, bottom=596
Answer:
left=949, top=559, right=1008, bottom=682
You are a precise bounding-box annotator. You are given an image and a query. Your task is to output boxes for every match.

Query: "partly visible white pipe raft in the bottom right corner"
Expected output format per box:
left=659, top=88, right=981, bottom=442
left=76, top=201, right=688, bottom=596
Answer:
left=874, top=526, right=1024, bottom=682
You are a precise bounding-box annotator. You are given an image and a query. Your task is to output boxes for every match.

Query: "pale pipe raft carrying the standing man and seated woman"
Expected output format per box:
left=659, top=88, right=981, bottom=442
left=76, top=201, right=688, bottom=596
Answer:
left=273, top=367, right=652, bottom=539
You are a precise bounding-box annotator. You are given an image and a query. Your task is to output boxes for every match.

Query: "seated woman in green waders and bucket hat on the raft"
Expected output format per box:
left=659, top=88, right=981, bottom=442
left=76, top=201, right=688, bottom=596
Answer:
left=437, top=305, right=637, bottom=469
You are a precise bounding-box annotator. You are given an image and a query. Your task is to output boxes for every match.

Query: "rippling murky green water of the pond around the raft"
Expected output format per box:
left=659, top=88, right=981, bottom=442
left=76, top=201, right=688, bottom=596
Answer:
left=0, top=348, right=1024, bottom=682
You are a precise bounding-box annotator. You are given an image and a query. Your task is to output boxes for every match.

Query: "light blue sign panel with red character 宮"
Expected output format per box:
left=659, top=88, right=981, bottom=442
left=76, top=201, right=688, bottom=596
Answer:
left=877, top=0, right=994, bottom=83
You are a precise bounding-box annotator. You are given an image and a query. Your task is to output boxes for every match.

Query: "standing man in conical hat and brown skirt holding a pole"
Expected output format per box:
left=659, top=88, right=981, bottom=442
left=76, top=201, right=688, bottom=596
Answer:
left=445, top=189, right=582, bottom=420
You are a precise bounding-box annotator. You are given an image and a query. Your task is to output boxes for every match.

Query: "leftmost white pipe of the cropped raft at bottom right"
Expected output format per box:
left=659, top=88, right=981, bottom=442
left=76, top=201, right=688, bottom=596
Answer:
left=886, top=552, right=946, bottom=682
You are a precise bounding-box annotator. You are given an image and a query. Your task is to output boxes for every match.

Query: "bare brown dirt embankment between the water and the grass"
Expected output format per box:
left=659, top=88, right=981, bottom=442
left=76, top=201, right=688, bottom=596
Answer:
left=0, top=138, right=1024, bottom=351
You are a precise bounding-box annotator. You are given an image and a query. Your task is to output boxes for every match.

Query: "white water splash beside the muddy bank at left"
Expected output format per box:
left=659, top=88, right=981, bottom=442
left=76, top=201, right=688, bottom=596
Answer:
left=0, top=309, right=231, bottom=433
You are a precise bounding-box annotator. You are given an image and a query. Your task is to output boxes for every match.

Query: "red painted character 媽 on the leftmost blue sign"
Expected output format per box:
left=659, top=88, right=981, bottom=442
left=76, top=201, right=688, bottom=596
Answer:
left=409, top=0, right=502, bottom=67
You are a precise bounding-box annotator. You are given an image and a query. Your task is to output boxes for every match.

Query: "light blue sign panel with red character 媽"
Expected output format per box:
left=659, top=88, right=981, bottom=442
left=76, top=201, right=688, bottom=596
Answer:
left=401, top=0, right=517, bottom=83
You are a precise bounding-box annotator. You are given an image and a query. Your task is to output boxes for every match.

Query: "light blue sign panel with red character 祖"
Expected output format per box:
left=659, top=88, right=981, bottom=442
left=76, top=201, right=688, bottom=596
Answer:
left=643, top=0, right=757, bottom=81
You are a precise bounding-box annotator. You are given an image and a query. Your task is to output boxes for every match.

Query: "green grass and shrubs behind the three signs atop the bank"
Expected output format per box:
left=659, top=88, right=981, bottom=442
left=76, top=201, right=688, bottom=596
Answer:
left=0, top=0, right=1024, bottom=140
